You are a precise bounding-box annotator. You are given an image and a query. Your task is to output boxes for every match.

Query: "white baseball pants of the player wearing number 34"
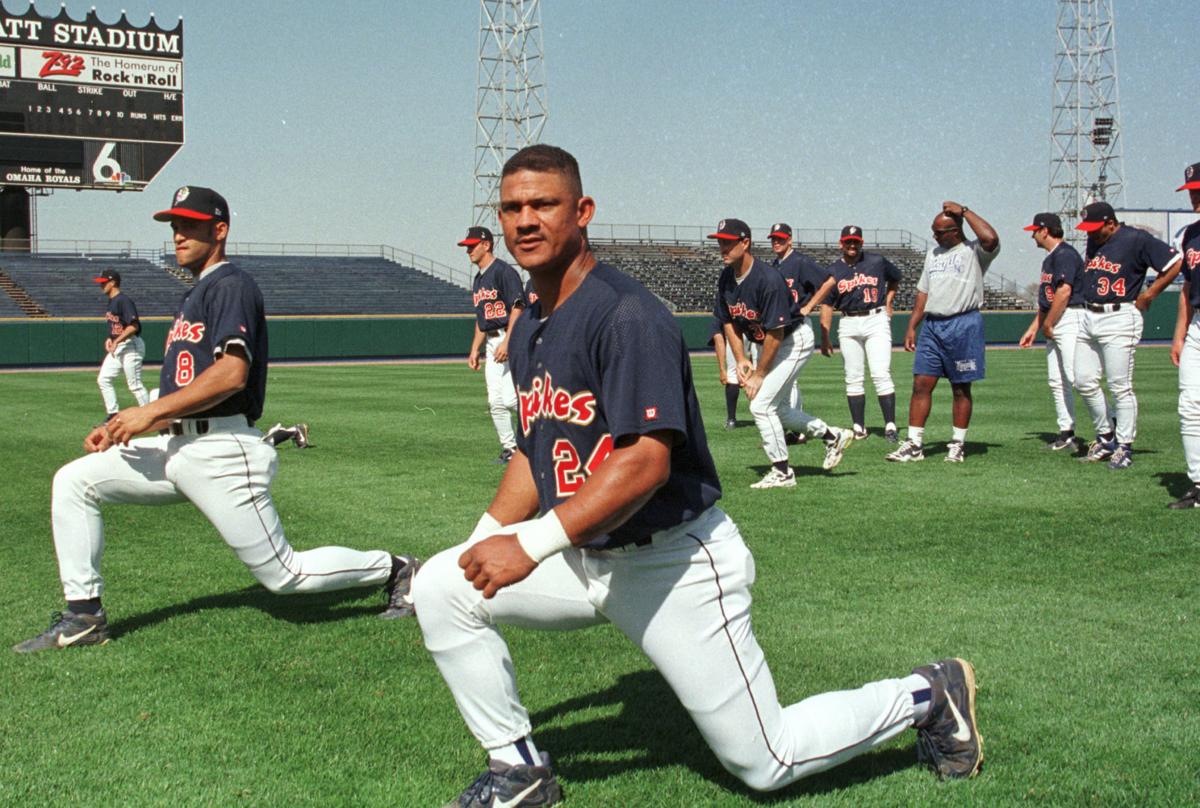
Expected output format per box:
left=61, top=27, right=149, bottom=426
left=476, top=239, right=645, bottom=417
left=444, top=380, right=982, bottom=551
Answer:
left=1075, top=304, right=1142, bottom=443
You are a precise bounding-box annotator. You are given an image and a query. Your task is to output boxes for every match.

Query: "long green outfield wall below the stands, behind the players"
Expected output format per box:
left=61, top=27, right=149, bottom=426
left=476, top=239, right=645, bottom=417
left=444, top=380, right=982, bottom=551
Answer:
left=0, top=292, right=1178, bottom=367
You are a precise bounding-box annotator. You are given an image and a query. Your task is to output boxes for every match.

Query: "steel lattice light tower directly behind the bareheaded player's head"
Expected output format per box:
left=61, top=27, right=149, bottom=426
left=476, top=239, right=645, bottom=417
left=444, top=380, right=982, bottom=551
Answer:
left=474, top=0, right=548, bottom=229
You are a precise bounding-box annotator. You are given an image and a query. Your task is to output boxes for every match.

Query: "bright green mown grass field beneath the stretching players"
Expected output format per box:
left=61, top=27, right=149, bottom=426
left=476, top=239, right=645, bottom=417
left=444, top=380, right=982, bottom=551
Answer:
left=0, top=347, right=1200, bottom=808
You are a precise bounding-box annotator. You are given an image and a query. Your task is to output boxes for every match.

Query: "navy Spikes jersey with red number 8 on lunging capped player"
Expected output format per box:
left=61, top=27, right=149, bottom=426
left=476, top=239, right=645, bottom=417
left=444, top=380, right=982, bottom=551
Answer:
left=158, top=263, right=266, bottom=423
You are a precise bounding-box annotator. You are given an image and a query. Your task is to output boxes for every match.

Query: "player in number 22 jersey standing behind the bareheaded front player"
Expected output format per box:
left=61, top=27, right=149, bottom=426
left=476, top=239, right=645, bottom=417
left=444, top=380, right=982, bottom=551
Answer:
left=458, top=227, right=524, bottom=463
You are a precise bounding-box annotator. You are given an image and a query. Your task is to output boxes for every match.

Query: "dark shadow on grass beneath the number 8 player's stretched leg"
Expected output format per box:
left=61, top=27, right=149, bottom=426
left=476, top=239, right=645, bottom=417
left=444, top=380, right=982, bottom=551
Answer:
left=112, top=585, right=384, bottom=638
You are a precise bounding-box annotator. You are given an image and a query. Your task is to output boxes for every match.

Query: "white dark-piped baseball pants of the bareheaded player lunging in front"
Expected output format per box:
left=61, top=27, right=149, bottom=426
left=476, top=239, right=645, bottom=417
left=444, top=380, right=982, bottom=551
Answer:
left=413, top=508, right=913, bottom=790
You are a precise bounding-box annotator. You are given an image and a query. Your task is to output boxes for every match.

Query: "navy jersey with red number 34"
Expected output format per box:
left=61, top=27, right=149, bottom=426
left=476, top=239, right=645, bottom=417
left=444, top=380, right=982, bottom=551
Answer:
left=1082, top=225, right=1177, bottom=303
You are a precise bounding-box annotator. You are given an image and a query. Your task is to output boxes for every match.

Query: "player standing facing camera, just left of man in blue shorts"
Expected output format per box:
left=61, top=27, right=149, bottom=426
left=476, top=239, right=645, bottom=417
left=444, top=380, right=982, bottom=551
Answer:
left=821, top=225, right=900, bottom=443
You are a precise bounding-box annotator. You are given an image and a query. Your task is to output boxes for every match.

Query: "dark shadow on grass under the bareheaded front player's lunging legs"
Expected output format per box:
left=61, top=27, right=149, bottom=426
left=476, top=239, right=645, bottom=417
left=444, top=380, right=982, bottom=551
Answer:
left=533, top=670, right=916, bottom=804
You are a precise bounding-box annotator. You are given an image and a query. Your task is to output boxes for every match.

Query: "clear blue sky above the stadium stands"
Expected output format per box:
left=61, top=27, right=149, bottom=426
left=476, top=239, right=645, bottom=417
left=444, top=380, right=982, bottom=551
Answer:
left=9, top=0, right=1200, bottom=282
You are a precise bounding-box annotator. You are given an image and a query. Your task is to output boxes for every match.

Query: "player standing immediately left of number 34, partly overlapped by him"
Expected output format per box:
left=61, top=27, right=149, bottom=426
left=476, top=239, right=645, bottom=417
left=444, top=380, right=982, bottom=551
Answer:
left=1018, top=213, right=1084, bottom=451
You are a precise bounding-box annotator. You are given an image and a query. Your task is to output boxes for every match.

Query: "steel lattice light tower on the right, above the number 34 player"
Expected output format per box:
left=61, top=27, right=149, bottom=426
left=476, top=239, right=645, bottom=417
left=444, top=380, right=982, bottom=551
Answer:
left=1049, top=0, right=1124, bottom=227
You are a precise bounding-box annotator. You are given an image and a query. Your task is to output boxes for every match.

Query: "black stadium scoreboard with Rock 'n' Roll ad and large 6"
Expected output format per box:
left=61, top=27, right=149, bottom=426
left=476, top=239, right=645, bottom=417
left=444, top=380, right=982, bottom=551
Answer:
left=0, top=7, right=184, bottom=191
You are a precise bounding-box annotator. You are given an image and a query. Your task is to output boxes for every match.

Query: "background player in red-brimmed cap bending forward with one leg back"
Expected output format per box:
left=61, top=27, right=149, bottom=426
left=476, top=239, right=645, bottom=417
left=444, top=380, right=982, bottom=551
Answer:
left=708, top=219, right=854, bottom=489
